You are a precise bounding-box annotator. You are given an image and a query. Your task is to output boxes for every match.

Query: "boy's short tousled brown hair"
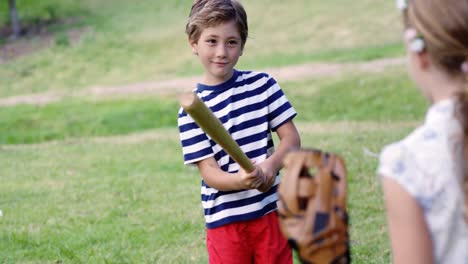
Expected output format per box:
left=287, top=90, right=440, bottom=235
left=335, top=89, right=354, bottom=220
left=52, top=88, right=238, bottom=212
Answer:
left=185, top=0, right=249, bottom=48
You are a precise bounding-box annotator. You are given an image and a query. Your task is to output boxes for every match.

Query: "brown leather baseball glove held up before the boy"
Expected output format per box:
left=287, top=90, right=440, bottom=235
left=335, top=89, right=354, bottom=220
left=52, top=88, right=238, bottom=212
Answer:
left=278, top=149, right=351, bottom=264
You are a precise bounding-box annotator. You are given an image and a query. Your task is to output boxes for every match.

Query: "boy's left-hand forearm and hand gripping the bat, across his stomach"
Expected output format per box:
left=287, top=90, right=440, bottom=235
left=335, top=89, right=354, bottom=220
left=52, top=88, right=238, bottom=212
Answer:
left=197, top=157, right=264, bottom=191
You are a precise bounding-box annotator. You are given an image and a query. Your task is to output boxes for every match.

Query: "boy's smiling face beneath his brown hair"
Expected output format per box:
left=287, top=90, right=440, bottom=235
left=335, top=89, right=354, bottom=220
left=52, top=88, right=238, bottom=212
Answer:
left=189, top=21, right=242, bottom=85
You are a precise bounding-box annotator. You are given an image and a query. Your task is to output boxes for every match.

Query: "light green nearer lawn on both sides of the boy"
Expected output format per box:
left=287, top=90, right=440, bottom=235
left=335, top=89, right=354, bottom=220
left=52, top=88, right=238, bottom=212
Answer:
left=0, top=122, right=410, bottom=263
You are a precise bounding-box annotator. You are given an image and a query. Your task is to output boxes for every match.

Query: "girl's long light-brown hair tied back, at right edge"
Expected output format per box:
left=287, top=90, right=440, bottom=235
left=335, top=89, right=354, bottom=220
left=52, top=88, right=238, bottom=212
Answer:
left=404, top=0, right=468, bottom=222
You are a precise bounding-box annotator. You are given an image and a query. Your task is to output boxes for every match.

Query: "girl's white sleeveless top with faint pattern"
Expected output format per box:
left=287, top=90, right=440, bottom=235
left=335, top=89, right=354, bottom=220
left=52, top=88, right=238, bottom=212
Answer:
left=378, top=99, right=468, bottom=264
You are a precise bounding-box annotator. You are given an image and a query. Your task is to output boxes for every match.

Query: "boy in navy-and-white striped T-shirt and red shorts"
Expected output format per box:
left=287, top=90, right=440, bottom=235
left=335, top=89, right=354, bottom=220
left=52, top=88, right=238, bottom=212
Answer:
left=178, top=0, right=300, bottom=263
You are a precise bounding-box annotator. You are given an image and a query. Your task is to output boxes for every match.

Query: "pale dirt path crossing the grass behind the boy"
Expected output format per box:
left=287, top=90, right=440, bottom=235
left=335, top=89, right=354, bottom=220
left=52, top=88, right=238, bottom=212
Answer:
left=0, top=58, right=405, bottom=106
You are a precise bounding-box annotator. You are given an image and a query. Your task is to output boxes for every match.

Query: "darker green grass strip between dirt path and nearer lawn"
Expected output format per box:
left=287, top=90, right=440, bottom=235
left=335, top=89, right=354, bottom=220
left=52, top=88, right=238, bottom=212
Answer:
left=0, top=68, right=427, bottom=144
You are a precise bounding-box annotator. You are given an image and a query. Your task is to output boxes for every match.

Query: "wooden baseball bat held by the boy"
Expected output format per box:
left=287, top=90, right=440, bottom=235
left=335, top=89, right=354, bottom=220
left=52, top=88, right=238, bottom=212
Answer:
left=179, top=92, right=255, bottom=172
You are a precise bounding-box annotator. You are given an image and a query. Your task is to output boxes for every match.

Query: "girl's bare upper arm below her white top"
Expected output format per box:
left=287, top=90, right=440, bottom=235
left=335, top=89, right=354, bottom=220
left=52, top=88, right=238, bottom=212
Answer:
left=382, top=177, right=434, bottom=264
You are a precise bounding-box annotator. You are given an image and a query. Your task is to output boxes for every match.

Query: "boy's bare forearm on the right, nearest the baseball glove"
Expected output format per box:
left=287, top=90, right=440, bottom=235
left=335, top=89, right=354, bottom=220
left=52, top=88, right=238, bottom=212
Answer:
left=259, top=120, right=301, bottom=187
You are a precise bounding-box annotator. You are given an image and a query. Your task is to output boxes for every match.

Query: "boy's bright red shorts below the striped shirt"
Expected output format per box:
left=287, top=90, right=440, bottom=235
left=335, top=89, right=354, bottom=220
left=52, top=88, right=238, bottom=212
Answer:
left=206, top=211, right=293, bottom=264
